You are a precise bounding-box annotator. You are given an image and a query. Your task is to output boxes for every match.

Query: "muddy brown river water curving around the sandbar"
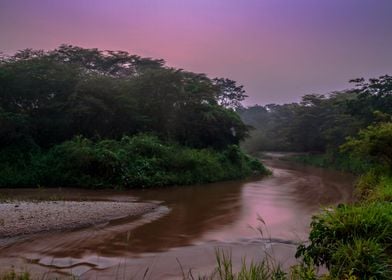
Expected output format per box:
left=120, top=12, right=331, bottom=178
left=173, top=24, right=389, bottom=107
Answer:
left=0, top=154, right=354, bottom=279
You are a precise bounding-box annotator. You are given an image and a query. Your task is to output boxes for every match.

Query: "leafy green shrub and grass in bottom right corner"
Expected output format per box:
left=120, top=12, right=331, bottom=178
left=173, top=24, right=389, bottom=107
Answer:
left=297, top=202, right=392, bottom=279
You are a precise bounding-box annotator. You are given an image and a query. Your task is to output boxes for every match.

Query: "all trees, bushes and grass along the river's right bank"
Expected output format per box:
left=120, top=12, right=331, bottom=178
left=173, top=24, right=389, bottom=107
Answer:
left=241, top=76, right=392, bottom=279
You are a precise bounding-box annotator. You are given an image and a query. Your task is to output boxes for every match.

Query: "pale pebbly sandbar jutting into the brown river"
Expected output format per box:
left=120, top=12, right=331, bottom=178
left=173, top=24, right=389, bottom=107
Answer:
left=0, top=201, right=157, bottom=238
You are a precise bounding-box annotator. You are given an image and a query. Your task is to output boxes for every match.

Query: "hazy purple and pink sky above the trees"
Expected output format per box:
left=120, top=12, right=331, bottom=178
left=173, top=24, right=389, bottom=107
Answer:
left=0, top=0, right=392, bottom=105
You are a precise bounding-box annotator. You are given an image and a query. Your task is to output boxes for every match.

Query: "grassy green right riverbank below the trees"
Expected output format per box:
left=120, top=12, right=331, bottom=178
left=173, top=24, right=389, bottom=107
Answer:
left=288, top=153, right=392, bottom=279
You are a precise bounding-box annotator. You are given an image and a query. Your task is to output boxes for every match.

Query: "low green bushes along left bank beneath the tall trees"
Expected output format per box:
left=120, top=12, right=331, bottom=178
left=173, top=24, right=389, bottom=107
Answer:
left=0, top=135, right=267, bottom=188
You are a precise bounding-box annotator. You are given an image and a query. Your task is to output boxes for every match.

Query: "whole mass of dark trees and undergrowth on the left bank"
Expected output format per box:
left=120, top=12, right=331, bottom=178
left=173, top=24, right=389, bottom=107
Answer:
left=0, top=45, right=265, bottom=187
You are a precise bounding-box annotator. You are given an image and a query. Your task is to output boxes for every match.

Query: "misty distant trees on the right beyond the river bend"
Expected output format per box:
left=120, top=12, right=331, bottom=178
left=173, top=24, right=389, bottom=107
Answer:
left=238, top=75, right=392, bottom=153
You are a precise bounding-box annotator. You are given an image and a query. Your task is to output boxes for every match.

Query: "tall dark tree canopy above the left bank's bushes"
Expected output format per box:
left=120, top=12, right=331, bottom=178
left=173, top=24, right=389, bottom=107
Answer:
left=0, top=45, right=248, bottom=148
